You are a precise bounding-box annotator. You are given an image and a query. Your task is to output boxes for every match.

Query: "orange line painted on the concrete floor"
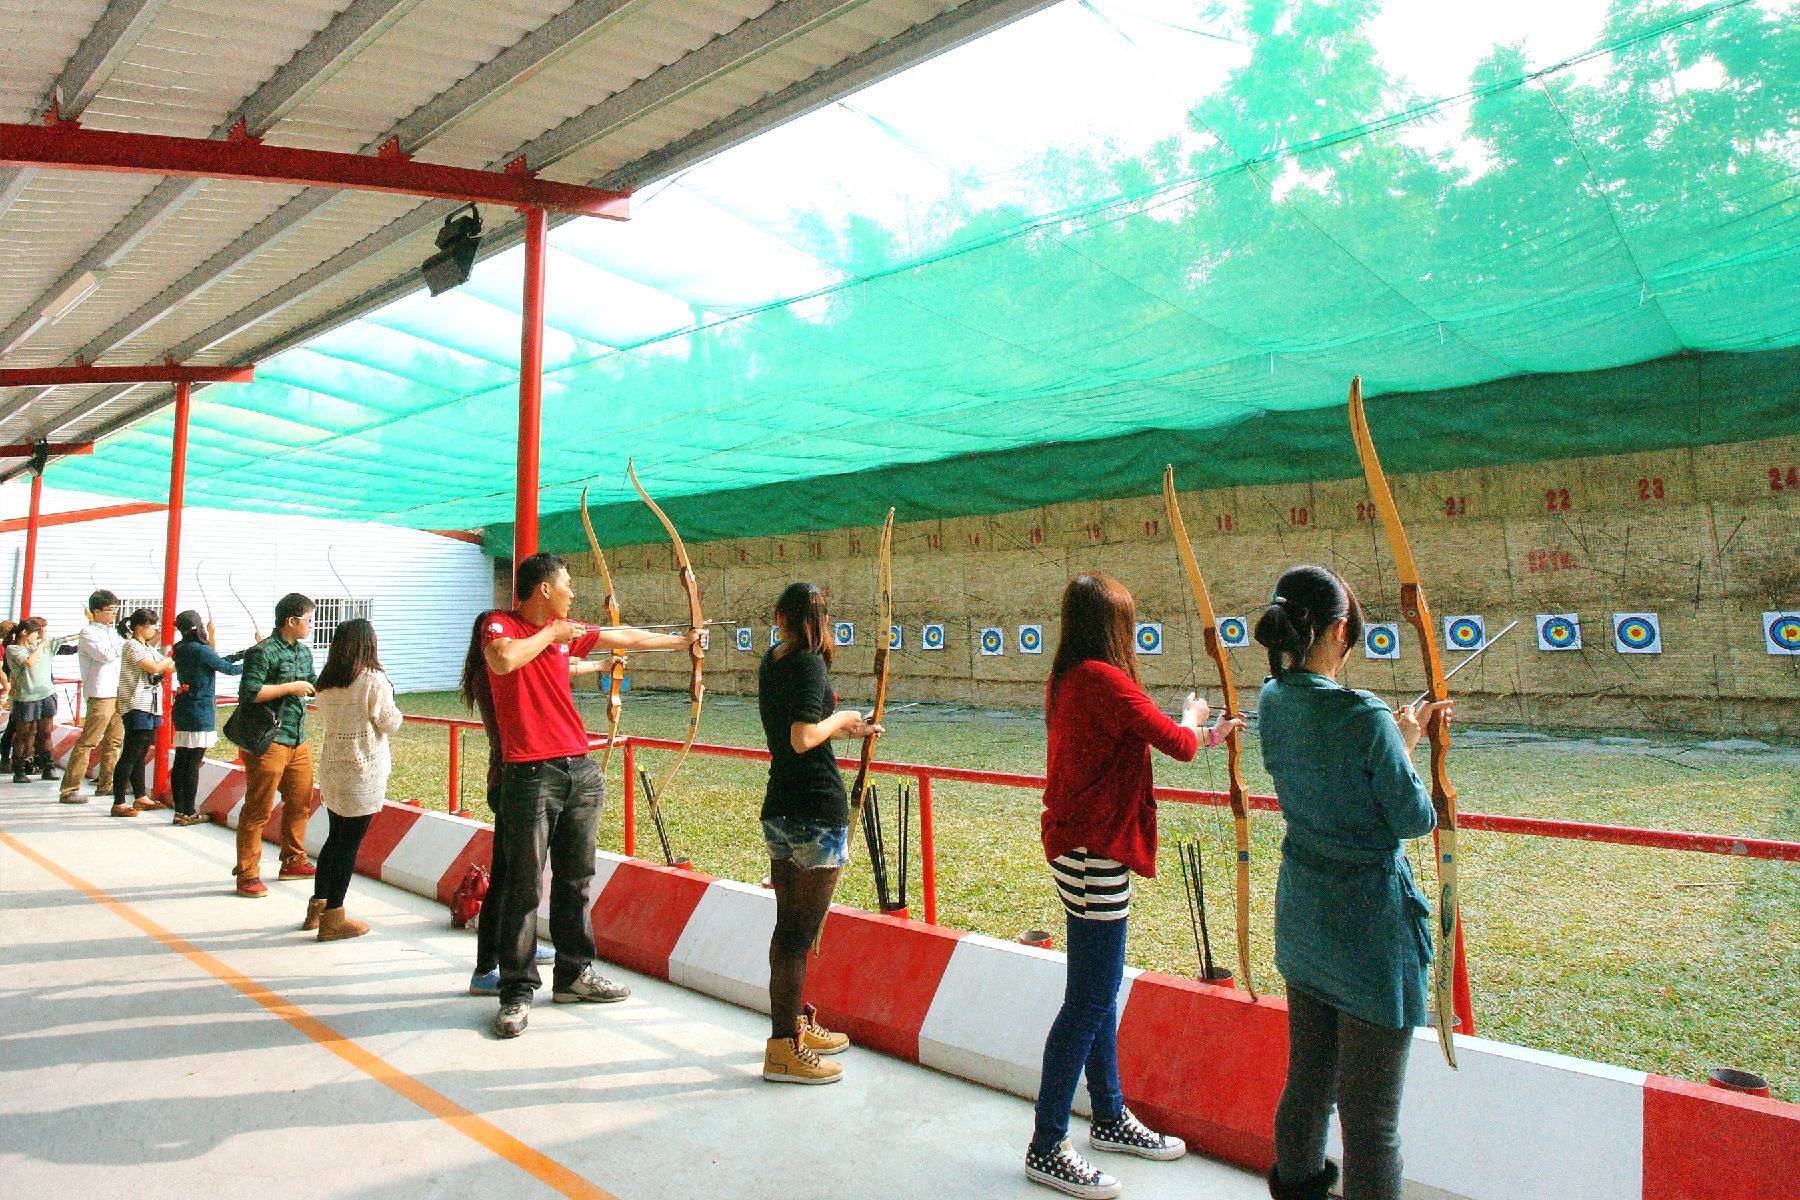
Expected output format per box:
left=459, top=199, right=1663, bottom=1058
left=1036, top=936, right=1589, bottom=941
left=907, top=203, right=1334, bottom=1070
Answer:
left=0, top=831, right=617, bottom=1200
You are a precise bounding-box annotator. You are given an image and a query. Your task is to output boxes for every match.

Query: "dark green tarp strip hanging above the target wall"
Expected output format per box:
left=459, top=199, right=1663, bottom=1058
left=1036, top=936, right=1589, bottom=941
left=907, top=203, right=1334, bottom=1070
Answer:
left=500, top=349, right=1800, bottom=558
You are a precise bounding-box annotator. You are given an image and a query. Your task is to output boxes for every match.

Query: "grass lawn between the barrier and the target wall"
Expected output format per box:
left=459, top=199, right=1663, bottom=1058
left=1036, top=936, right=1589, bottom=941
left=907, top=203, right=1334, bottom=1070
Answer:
left=243, top=693, right=1800, bottom=1099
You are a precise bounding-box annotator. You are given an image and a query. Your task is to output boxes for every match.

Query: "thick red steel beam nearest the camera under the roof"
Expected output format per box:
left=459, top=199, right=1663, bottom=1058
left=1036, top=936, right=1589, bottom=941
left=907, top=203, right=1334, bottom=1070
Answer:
left=0, top=121, right=630, bottom=221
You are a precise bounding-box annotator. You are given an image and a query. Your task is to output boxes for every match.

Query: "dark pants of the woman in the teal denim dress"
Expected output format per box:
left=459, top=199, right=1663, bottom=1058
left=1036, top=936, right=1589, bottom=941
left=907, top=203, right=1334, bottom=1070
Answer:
left=1274, top=988, right=1413, bottom=1200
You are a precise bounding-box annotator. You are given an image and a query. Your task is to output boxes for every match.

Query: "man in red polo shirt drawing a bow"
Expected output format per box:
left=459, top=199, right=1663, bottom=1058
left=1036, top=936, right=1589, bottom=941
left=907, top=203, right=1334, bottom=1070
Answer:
left=482, top=554, right=698, bottom=1038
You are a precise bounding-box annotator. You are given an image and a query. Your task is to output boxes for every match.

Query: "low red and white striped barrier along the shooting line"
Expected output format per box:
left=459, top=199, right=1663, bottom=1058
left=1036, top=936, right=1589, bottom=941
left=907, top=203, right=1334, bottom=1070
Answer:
left=56, top=738, right=1800, bottom=1200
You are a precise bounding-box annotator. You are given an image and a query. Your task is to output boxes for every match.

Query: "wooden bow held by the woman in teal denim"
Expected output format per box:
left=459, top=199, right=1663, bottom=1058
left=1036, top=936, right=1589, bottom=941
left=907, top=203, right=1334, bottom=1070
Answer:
left=1350, top=376, right=1458, bottom=1067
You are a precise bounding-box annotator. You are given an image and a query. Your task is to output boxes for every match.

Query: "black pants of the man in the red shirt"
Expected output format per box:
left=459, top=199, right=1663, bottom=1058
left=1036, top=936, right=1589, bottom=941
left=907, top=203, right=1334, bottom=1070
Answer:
left=493, top=756, right=607, bottom=1004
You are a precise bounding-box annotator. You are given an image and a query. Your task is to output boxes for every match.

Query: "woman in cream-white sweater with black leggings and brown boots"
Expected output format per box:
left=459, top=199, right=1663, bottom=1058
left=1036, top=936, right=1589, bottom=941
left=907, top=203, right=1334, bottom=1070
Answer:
left=301, top=617, right=403, bottom=941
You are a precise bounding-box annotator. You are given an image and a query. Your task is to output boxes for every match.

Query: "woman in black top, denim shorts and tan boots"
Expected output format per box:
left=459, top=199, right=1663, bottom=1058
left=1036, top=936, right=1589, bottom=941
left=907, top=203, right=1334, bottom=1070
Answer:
left=756, top=583, right=880, bottom=1083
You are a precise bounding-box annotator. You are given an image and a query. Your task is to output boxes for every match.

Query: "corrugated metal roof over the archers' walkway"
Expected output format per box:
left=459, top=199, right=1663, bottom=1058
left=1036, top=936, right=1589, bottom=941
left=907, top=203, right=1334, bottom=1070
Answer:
left=0, top=0, right=1046, bottom=455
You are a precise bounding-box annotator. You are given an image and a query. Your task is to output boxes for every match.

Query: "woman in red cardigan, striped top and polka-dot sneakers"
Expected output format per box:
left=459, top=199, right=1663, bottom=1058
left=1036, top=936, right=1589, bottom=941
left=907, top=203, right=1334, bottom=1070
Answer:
left=1024, top=574, right=1244, bottom=1200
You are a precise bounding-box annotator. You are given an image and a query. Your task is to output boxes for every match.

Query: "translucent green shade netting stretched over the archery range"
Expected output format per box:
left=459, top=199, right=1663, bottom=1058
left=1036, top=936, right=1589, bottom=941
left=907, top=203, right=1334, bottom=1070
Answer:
left=54, top=0, right=1800, bottom=549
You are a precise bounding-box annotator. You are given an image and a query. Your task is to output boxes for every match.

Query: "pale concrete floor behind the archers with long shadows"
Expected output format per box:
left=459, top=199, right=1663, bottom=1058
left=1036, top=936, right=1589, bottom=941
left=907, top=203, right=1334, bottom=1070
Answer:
left=0, top=783, right=1265, bottom=1200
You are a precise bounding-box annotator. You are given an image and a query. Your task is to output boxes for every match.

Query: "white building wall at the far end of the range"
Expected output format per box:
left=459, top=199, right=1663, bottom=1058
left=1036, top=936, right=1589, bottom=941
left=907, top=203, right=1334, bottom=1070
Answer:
left=0, top=473, right=493, bottom=693
